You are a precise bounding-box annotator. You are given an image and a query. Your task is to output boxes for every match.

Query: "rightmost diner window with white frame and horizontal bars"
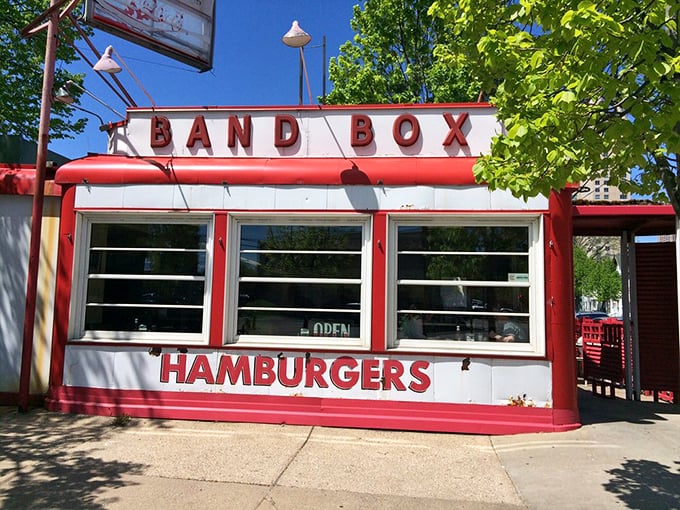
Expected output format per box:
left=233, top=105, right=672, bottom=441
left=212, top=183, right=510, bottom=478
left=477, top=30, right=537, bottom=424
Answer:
left=388, top=215, right=544, bottom=354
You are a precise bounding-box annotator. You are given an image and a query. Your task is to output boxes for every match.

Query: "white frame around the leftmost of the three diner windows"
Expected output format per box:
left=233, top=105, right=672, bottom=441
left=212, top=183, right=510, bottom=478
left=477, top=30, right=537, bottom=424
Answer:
left=69, top=211, right=214, bottom=344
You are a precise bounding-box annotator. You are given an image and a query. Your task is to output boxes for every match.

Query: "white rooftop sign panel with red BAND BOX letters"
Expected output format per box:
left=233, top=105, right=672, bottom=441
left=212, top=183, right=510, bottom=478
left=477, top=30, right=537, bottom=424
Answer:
left=113, top=105, right=500, bottom=157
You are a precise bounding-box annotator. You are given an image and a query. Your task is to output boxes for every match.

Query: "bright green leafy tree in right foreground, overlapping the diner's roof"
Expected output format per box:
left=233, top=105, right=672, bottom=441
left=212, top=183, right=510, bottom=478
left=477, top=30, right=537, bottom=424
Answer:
left=430, top=0, right=680, bottom=213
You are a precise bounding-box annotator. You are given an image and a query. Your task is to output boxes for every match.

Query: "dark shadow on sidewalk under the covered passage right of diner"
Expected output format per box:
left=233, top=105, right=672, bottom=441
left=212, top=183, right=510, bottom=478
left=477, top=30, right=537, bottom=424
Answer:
left=578, top=388, right=680, bottom=425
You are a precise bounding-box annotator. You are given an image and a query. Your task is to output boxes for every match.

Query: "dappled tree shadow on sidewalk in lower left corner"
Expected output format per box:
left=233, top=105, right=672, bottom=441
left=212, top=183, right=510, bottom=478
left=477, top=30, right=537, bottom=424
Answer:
left=0, top=410, right=145, bottom=510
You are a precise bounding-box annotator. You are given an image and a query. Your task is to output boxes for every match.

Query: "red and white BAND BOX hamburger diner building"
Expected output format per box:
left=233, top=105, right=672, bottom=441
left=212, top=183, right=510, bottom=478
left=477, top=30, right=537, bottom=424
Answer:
left=46, top=103, right=579, bottom=434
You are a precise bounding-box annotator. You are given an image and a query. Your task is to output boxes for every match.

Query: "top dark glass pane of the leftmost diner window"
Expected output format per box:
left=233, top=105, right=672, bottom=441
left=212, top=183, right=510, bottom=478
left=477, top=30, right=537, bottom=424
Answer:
left=90, top=223, right=207, bottom=249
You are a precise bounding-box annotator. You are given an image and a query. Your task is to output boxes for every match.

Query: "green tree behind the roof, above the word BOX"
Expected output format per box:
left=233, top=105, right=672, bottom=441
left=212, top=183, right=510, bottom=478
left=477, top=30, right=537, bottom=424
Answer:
left=326, top=0, right=480, bottom=104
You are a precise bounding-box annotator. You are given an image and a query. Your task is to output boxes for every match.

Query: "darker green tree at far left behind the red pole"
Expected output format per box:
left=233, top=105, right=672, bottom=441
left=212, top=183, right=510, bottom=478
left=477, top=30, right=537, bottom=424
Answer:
left=0, top=0, right=86, bottom=141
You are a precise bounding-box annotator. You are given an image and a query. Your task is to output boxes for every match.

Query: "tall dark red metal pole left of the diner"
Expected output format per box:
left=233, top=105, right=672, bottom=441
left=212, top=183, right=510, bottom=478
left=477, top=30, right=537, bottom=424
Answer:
left=19, top=0, right=59, bottom=412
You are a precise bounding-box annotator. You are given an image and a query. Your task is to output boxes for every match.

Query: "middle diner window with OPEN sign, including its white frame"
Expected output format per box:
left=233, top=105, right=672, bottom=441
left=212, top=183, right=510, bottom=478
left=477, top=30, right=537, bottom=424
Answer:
left=226, top=215, right=370, bottom=348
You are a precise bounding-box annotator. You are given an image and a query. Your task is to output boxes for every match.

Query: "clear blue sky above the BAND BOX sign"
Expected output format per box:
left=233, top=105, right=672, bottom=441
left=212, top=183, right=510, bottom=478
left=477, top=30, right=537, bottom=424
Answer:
left=50, top=0, right=360, bottom=158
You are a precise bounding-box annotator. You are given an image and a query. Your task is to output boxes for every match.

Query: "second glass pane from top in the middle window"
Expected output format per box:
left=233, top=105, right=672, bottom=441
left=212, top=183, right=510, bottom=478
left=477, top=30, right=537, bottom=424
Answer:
left=241, top=252, right=361, bottom=278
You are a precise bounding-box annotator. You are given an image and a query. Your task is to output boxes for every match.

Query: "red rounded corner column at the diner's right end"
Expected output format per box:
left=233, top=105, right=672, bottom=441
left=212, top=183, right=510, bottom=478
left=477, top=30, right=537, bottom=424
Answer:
left=546, top=190, right=579, bottom=422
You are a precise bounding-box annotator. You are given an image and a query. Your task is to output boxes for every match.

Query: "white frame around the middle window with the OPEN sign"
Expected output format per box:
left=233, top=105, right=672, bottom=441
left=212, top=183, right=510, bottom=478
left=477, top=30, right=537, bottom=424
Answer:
left=223, top=212, right=373, bottom=350
